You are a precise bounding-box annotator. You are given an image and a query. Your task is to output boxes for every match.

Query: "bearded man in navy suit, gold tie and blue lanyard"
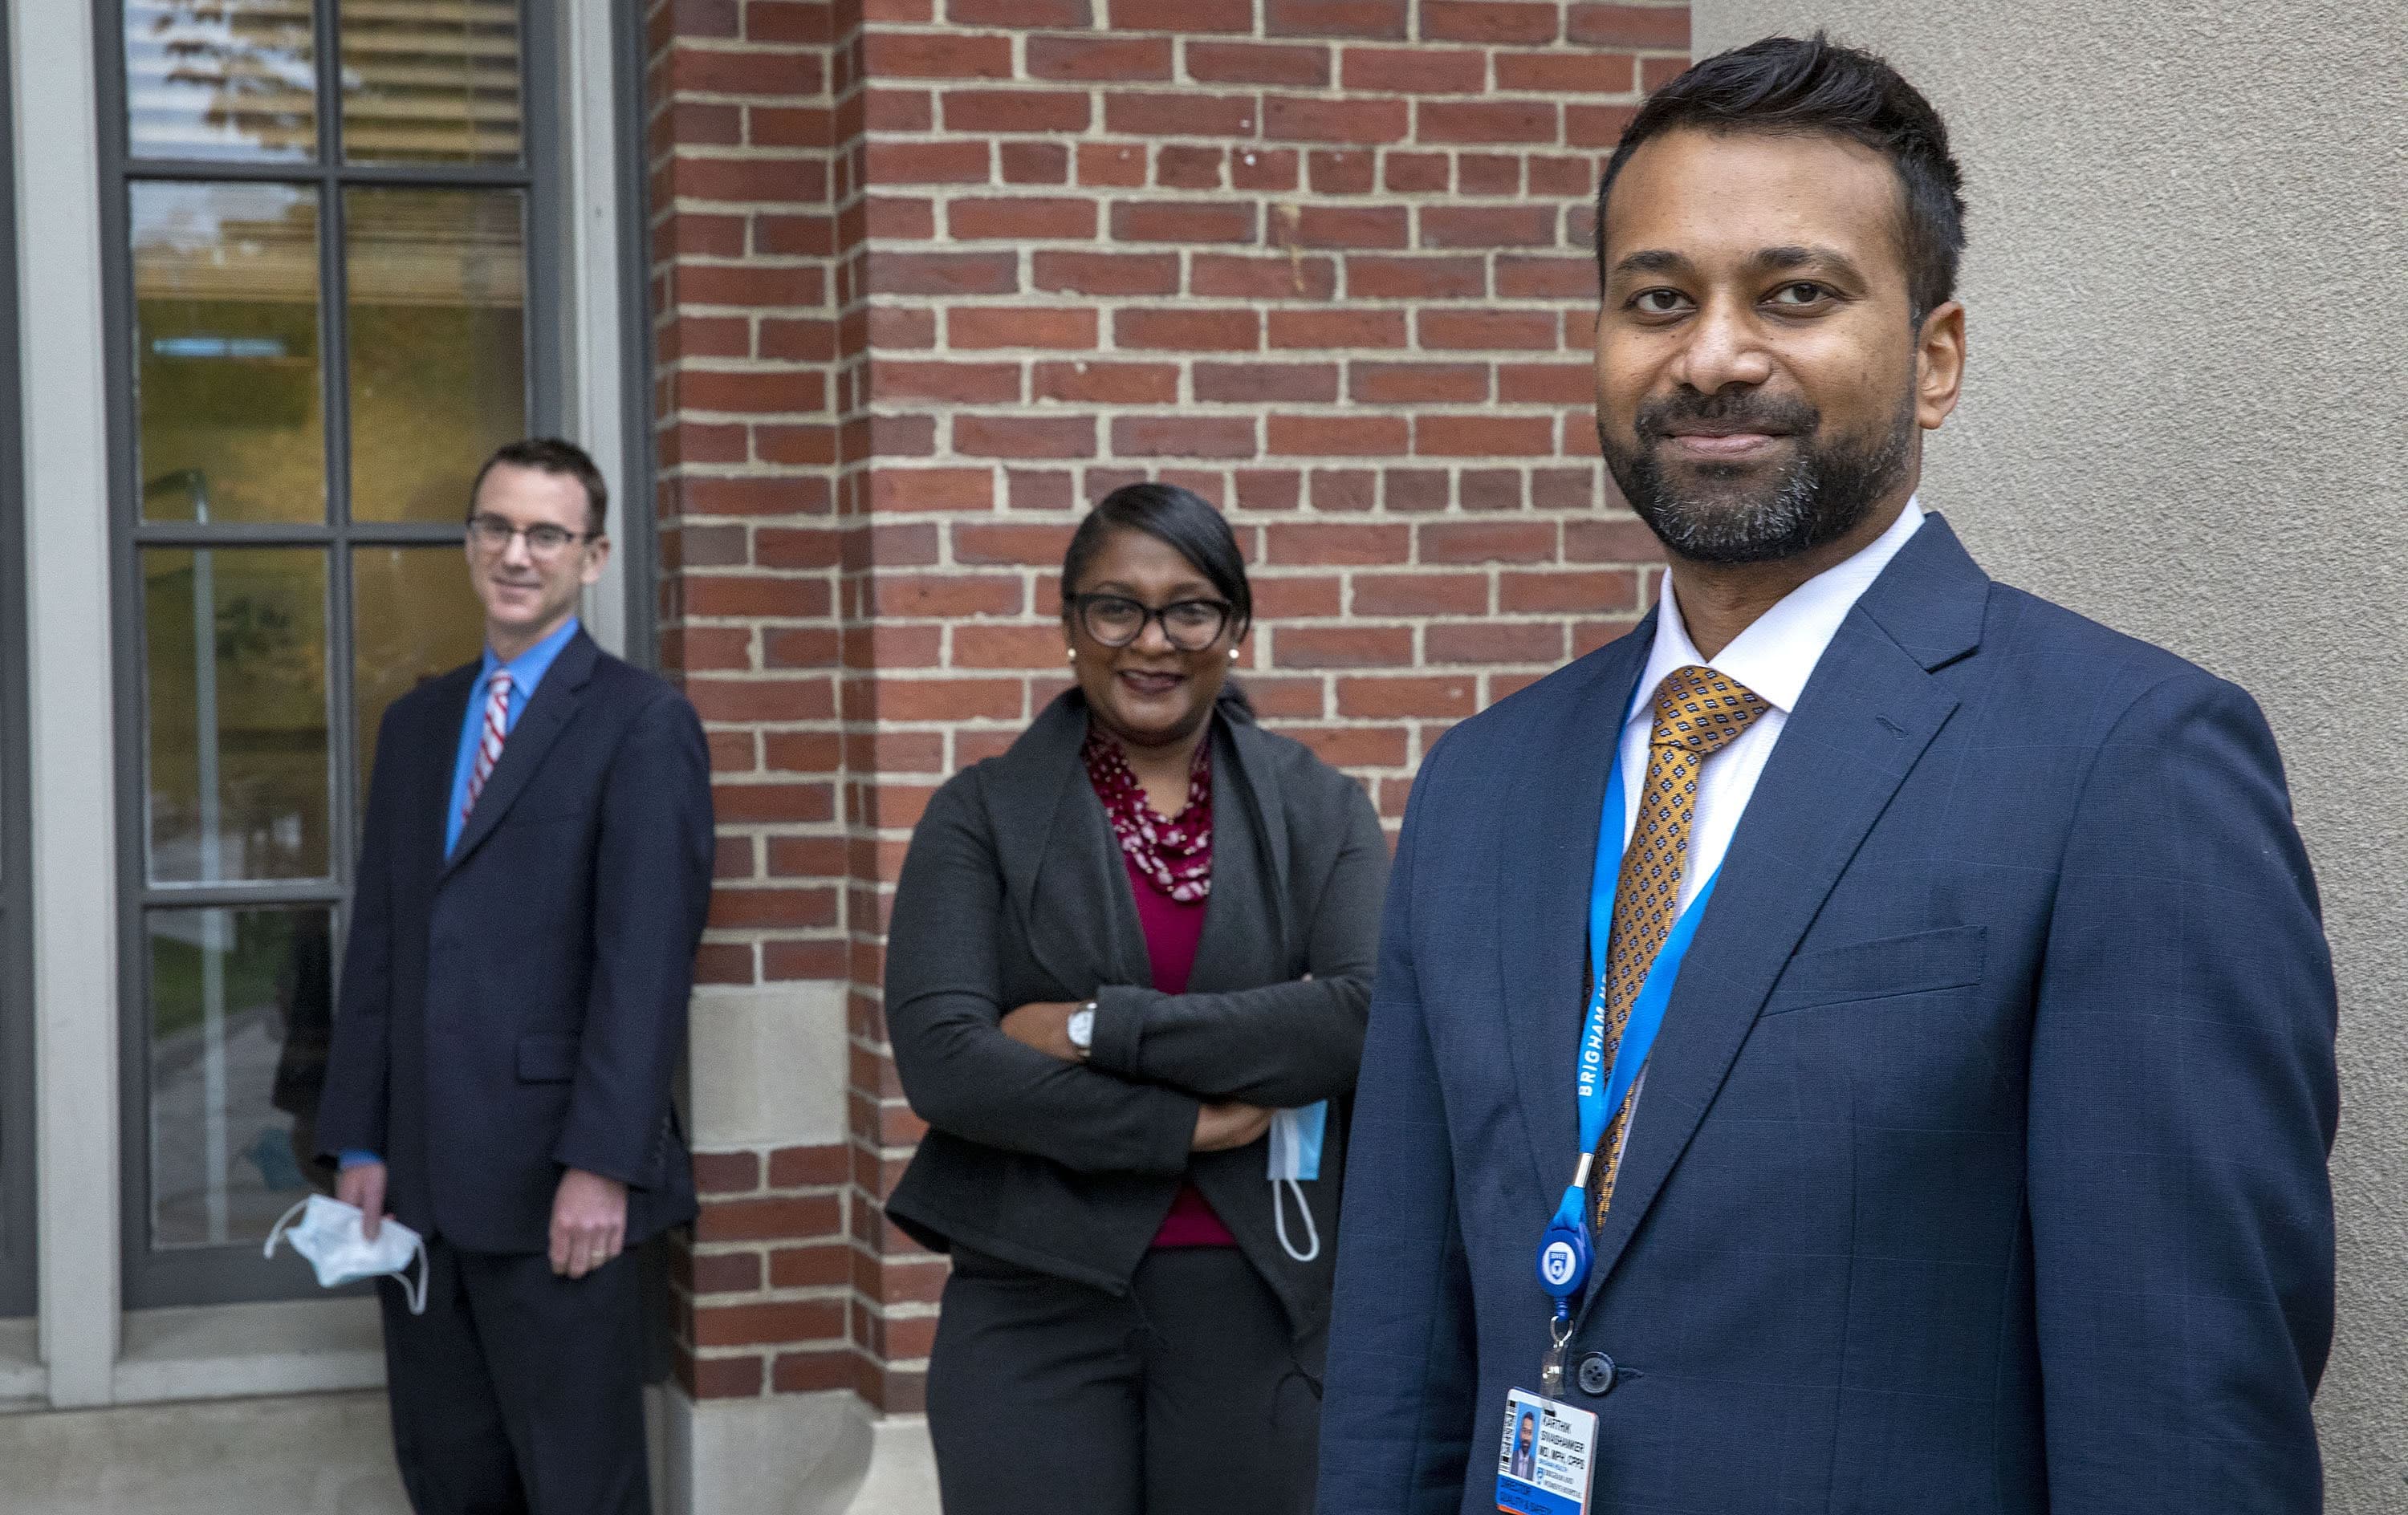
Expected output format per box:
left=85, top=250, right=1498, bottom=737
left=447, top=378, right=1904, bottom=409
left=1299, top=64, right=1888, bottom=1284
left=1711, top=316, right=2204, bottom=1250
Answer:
left=1320, top=36, right=2338, bottom=1515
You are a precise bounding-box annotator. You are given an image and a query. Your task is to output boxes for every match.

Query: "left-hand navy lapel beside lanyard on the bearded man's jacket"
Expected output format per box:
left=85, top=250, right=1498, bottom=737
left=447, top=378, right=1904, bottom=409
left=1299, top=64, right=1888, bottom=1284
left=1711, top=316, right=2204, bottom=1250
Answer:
left=1495, top=614, right=1654, bottom=1195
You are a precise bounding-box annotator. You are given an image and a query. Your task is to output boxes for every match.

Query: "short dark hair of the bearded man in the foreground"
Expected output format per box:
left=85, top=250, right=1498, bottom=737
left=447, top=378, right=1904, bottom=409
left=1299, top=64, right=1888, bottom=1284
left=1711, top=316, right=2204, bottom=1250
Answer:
left=1597, top=31, right=1965, bottom=325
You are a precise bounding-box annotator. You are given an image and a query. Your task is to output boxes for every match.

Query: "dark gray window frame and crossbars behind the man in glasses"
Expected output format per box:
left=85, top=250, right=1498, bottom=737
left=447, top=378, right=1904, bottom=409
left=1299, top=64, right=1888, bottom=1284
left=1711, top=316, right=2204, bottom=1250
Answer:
left=94, top=0, right=563, bottom=1310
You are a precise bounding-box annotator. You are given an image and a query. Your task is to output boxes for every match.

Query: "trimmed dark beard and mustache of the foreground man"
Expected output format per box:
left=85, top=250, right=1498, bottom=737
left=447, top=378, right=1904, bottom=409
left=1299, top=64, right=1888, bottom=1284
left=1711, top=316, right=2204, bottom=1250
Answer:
left=1597, top=390, right=1914, bottom=563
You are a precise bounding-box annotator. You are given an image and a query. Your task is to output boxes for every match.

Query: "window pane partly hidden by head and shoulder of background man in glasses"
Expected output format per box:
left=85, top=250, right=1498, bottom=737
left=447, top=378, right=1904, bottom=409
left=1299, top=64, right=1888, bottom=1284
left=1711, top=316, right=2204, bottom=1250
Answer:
left=352, top=546, right=484, bottom=795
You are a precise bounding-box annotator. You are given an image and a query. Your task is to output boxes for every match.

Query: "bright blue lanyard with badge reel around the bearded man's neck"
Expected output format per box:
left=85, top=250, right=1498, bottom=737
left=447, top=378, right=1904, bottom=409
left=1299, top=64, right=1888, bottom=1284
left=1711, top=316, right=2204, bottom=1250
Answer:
left=1539, top=688, right=1722, bottom=1320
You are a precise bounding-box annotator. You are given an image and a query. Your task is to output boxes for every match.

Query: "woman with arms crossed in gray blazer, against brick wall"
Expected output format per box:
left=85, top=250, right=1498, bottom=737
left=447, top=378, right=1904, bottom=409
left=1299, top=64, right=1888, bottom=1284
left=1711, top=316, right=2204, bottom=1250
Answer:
left=886, top=484, right=1387, bottom=1515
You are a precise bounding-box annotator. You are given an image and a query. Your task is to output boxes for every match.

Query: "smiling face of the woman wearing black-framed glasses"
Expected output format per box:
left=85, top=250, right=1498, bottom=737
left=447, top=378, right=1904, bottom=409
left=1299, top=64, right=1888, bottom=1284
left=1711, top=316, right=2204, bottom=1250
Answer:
left=1062, top=527, right=1245, bottom=749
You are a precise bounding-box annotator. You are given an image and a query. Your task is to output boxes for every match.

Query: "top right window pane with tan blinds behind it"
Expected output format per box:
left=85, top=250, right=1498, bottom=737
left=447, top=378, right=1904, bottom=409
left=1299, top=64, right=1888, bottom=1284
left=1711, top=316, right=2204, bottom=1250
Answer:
left=342, top=0, right=518, bottom=164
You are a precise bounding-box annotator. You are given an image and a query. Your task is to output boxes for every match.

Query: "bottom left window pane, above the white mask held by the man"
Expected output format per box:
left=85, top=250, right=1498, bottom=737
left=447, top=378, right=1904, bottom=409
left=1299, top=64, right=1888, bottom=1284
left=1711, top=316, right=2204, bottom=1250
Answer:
left=147, top=906, right=335, bottom=1242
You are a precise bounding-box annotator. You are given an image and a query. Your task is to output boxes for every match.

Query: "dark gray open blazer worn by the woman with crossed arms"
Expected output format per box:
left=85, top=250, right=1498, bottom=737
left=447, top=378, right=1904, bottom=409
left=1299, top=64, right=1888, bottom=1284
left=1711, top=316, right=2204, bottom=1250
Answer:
left=886, top=688, right=1387, bottom=1339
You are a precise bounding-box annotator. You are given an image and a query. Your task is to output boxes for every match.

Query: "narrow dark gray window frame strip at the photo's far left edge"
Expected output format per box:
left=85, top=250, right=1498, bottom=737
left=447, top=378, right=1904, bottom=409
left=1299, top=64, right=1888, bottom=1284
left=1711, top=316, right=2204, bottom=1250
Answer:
left=0, top=11, right=39, bottom=1320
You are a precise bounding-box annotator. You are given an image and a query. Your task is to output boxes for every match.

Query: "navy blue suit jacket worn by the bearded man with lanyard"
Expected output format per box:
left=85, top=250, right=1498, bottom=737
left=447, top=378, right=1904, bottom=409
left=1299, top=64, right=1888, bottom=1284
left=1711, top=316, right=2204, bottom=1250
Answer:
left=1320, top=518, right=2338, bottom=1515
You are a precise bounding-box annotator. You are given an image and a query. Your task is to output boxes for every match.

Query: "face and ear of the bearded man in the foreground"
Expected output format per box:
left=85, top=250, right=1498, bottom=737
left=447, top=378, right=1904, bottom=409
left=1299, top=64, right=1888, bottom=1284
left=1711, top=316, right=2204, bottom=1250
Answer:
left=1597, top=130, right=1965, bottom=563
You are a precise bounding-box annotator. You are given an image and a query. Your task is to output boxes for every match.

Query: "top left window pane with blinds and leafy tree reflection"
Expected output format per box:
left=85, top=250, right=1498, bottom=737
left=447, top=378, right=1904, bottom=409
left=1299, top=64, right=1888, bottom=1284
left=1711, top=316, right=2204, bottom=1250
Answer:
left=125, top=0, right=318, bottom=159
